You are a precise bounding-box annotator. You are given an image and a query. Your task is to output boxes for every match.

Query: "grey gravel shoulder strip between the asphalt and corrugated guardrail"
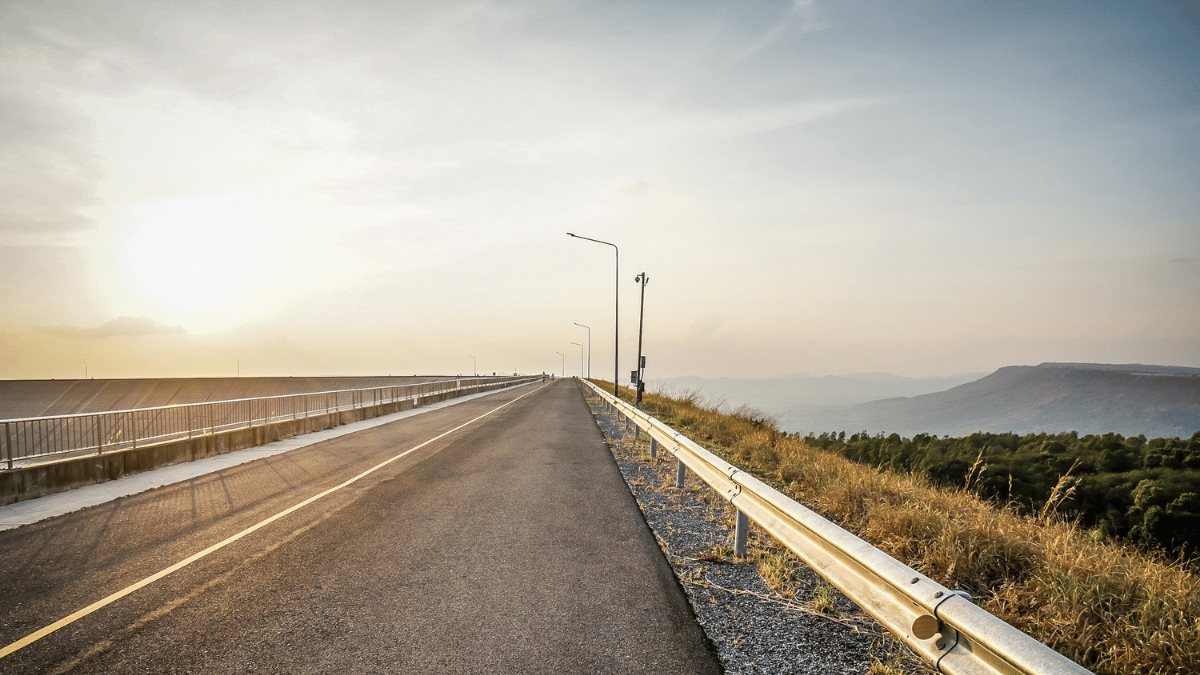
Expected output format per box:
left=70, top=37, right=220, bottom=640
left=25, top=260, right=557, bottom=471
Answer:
left=583, top=389, right=930, bottom=675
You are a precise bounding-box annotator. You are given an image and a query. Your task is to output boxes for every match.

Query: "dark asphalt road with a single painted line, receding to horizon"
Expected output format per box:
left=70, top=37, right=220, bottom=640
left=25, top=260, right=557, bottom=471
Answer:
left=0, top=381, right=720, bottom=674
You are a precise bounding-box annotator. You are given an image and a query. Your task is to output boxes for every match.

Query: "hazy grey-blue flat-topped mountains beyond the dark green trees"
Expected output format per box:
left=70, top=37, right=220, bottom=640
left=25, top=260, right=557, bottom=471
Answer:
left=662, top=363, right=1200, bottom=437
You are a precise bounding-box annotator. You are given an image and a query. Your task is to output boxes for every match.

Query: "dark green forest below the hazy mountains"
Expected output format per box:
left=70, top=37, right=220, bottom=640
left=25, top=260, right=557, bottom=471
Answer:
left=804, top=431, right=1200, bottom=556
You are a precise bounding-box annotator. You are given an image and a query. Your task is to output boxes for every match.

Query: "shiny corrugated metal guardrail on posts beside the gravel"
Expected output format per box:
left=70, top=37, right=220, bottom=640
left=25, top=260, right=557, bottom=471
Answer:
left=584, top=381, right=1091, bottom=675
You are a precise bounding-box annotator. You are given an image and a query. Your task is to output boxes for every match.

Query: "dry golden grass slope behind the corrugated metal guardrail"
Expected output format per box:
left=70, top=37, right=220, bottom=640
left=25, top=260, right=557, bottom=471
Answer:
left=598, top=382, right=1200, bottom=675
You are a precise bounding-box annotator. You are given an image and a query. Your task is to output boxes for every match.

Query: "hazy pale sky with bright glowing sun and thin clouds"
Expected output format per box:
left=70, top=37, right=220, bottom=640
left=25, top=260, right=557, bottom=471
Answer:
left=0, top=0, right=1200, bottom=380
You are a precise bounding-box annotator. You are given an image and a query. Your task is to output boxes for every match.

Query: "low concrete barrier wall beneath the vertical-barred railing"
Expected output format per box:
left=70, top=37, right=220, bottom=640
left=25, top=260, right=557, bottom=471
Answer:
left=0, top=382, right=525, bottom=506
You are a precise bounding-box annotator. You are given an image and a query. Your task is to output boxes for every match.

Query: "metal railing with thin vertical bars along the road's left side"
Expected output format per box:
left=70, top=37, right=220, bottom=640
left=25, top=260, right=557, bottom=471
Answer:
left=0, top=375, right=541, bottom=468
